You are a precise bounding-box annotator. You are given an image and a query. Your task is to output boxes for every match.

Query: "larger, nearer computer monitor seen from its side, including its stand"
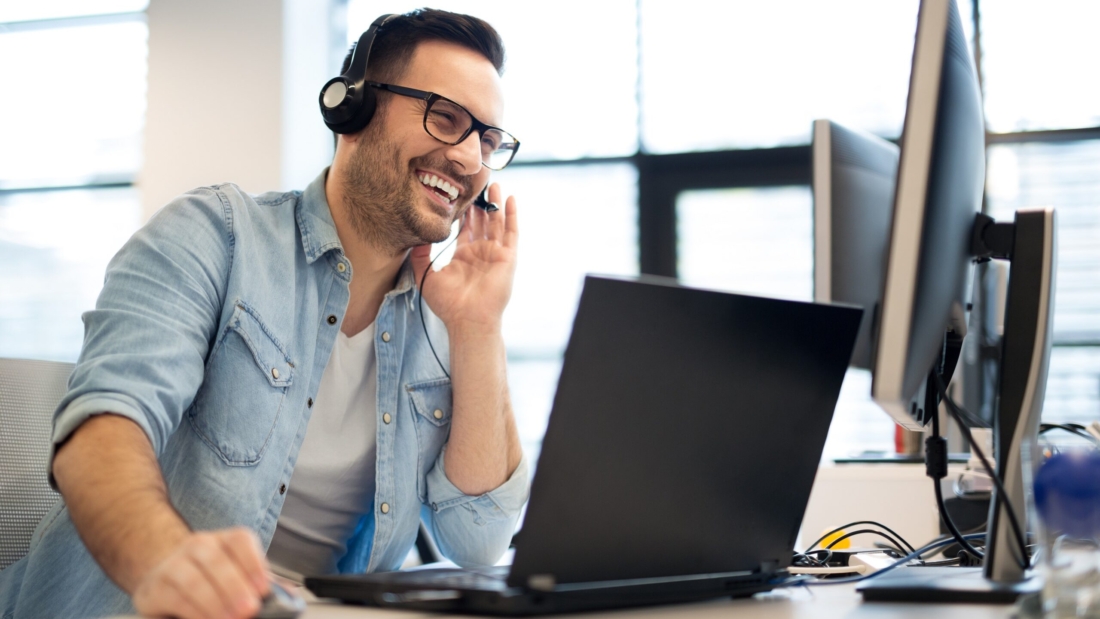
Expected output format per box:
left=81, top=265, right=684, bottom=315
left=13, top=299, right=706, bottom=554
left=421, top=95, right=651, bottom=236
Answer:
left=861, top=0, right=1055, bottom=601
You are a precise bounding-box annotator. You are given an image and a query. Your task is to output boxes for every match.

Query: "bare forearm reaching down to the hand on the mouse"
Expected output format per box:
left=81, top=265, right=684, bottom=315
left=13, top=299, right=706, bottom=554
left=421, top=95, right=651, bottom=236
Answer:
left=53, top=414, right=190, bottom=595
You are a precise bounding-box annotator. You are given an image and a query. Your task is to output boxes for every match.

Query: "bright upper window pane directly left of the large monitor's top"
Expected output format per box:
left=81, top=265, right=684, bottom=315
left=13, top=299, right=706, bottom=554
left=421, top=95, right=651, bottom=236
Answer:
left=641, top=0, right=917, bottom=153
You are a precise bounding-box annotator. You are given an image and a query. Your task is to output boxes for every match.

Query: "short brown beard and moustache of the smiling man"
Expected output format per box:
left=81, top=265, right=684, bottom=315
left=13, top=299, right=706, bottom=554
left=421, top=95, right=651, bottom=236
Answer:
left=343, top=123, right=472, bottom=255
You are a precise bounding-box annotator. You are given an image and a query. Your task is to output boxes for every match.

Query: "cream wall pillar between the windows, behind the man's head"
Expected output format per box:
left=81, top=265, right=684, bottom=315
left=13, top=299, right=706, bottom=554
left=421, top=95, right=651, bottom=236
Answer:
left=138, top=0, right=344, bottom=219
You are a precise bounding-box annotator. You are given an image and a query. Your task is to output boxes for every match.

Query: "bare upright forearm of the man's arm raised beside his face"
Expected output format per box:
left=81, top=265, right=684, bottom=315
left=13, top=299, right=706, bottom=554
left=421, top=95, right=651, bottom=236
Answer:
left=446, top=325, right=523, bottom=495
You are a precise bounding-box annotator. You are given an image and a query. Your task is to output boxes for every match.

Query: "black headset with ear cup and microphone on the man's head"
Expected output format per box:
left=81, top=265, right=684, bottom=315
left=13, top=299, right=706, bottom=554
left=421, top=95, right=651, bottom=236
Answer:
left=318, top=13, right=499, bottom=212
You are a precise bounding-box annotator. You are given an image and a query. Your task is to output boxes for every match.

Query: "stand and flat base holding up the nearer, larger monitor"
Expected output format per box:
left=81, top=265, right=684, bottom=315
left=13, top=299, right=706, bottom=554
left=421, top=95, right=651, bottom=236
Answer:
left=856, top=208, right=1056, bottom=604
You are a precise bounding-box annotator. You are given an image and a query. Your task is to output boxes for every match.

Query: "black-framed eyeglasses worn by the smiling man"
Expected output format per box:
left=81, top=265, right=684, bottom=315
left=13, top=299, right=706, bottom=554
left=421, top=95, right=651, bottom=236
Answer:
left=366, top=81, right=519, bottom=169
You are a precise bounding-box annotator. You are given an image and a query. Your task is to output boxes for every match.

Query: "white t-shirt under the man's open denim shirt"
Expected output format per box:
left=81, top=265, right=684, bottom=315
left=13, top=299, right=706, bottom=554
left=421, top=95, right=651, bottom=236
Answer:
left=267, top=323, right=378, bottom=579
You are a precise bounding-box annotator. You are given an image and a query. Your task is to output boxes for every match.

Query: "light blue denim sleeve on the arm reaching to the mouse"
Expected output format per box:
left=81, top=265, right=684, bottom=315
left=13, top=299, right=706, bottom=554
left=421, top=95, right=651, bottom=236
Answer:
left=50, top=188, right=233, bottom=484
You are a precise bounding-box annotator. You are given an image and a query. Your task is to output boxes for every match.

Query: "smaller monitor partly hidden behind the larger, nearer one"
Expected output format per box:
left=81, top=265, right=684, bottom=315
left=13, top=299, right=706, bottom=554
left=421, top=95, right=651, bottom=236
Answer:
left=811, top=120, right=898, bottom=369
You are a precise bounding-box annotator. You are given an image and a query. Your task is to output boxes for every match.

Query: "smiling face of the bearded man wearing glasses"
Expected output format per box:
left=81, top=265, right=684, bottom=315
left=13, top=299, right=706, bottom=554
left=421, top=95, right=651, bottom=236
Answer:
left=345, top=41, right=504, bottom=250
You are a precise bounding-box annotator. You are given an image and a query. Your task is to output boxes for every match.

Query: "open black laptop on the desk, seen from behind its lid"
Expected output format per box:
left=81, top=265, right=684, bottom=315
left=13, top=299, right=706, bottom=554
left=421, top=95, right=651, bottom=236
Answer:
left=306, top=276, right=862, bottom=616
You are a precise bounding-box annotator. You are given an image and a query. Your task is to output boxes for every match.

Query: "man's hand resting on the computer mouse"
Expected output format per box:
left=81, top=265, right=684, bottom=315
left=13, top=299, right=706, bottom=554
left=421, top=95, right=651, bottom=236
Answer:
left=133, top=527, right=271, bottom=619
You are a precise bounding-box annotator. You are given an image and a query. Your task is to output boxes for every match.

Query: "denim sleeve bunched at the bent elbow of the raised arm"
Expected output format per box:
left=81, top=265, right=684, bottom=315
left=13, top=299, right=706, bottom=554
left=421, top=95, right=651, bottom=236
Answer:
left=427, top=446, right=529, bottom=567
